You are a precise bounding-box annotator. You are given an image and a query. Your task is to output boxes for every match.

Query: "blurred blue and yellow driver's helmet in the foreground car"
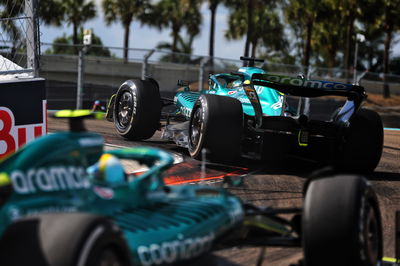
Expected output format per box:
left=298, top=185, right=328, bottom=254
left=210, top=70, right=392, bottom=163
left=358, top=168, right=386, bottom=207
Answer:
left=88, top=153, right=125, bottom=184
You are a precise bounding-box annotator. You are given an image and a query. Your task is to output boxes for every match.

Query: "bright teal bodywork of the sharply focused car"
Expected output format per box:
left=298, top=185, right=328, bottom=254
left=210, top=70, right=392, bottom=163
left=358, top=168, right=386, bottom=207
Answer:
left=174, top=67, right=284, bottom=118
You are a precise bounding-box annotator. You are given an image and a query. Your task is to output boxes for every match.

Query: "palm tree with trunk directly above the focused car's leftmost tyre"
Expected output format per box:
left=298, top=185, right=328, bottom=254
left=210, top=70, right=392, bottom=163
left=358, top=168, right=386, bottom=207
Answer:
left=102, top=0, right=149, bottom=62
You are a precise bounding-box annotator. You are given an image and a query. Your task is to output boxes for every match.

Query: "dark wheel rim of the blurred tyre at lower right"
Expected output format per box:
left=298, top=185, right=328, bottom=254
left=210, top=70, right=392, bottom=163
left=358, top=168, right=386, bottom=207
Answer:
left=365, top=206, right=380, bottom=263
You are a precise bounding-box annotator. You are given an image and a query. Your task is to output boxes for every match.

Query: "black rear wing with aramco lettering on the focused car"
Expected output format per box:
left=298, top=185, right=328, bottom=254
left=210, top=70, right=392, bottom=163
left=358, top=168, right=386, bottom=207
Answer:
left=252, top=74, right=367, bottom=100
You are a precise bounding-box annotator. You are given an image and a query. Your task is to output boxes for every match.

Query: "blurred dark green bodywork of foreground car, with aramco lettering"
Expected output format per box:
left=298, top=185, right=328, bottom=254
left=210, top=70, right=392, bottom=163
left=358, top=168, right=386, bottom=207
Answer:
left=0, top=125, right=243, bottom=265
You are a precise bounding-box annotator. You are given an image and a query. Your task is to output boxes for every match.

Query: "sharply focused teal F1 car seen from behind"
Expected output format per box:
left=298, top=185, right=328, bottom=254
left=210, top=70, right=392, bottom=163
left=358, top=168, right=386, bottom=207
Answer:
left=107, top=58, right=383, bottom=172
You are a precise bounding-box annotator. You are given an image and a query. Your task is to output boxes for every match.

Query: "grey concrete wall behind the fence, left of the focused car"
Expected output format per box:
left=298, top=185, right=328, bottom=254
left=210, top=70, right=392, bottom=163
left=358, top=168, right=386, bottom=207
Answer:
left=40, top=55, right=203, bottom=109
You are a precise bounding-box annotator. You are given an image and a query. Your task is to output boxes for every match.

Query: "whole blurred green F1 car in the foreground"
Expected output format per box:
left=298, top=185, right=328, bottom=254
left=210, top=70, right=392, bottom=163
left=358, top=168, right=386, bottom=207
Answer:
left=0, top=112, right=382, bottom=266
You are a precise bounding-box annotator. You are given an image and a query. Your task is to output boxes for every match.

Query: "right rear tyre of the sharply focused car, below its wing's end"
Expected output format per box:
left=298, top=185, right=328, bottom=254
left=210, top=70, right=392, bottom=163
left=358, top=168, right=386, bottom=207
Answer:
left=336, top=109, right=383, bottom=173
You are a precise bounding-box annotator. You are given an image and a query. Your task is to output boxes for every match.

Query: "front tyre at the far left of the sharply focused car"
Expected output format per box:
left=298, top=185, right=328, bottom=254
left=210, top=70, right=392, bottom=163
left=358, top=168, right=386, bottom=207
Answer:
left=113, top=79, right=161, bottom=140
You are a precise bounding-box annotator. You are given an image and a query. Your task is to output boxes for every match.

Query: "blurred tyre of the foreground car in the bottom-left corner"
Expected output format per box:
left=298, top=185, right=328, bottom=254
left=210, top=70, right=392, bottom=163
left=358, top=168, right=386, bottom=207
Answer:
left=0, top=213, right=131, bottom=266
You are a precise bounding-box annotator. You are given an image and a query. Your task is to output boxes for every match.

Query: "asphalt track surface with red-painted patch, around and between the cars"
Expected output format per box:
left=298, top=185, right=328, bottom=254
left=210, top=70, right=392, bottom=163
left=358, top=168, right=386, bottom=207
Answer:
left=48, top=118, right=400, bottom=265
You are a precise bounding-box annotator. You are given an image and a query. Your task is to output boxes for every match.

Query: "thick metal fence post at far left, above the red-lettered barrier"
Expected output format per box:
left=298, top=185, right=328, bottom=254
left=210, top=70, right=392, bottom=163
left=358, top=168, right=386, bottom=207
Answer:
left=25, top=0, right=40, bottom=77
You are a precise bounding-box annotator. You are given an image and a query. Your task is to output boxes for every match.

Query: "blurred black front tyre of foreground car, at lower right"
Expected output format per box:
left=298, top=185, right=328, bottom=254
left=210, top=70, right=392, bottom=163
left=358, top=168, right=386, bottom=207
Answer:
left=302, top=176, right=382, bottom=266
